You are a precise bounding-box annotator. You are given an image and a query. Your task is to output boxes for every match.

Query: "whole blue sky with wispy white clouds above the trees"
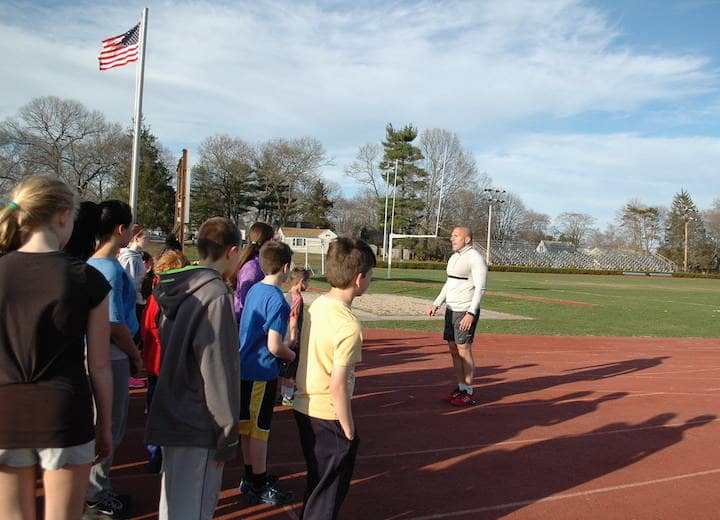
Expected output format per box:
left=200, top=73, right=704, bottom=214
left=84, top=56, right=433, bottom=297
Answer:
left=0, top=0, right=720, bottom=228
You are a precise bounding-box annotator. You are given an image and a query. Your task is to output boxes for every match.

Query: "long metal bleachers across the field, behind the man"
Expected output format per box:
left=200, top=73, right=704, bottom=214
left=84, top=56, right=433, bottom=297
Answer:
left=475, top=242, right=677, bottom=273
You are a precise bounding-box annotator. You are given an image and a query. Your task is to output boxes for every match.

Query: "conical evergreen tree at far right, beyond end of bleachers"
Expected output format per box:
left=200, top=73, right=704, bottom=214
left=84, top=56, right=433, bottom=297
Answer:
left=658, top=189, right=713, bottom=271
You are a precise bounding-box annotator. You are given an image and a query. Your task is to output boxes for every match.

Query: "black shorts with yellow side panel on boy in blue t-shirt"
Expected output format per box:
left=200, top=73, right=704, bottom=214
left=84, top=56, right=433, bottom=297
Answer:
left=240, top=379, right=277, bottom=442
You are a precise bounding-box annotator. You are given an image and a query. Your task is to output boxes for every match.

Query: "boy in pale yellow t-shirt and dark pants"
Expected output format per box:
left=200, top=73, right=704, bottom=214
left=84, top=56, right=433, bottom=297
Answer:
left=294, top=238, right=376, bottom=520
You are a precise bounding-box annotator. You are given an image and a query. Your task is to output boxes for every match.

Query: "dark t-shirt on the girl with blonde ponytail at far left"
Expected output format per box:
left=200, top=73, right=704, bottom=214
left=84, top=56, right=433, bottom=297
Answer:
left=0, top=251, right=110, bottom=449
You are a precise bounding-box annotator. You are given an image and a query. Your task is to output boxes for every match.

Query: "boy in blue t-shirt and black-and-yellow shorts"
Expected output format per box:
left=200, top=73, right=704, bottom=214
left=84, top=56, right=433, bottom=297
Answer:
left=240, top=241, right=296, bottom=505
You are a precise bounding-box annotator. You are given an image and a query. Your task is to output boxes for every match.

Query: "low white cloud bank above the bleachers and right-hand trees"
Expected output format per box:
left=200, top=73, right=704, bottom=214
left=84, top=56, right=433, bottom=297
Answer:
left=477, top=134, right=720, bottom=227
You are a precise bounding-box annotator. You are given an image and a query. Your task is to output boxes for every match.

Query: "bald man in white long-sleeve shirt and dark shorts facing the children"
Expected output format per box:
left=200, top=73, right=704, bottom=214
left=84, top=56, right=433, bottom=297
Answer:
left=428, top=227, right=488, bottom=406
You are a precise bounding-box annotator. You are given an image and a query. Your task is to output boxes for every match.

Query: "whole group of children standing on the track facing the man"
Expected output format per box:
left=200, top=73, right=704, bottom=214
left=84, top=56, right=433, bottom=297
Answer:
left=0, top=177, right=375, bottom=520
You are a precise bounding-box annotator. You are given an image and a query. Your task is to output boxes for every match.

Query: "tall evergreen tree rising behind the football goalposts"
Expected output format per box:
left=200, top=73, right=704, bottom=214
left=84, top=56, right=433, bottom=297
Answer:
left=380, top=123, right=427, bottom=233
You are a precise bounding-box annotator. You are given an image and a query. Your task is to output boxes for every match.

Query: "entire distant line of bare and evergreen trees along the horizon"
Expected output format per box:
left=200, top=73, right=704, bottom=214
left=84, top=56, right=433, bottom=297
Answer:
left=0, top=96, right=720, bottom=271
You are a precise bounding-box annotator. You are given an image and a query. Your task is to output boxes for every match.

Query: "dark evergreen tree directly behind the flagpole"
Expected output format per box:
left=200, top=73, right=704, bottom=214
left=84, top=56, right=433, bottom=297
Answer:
left=109, top=126, right=175, bottom=233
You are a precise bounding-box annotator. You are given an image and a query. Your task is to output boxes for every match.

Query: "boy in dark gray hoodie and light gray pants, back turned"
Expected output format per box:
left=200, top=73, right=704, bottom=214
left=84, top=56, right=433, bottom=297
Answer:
left=145, top=217, right=240, bottom=520
